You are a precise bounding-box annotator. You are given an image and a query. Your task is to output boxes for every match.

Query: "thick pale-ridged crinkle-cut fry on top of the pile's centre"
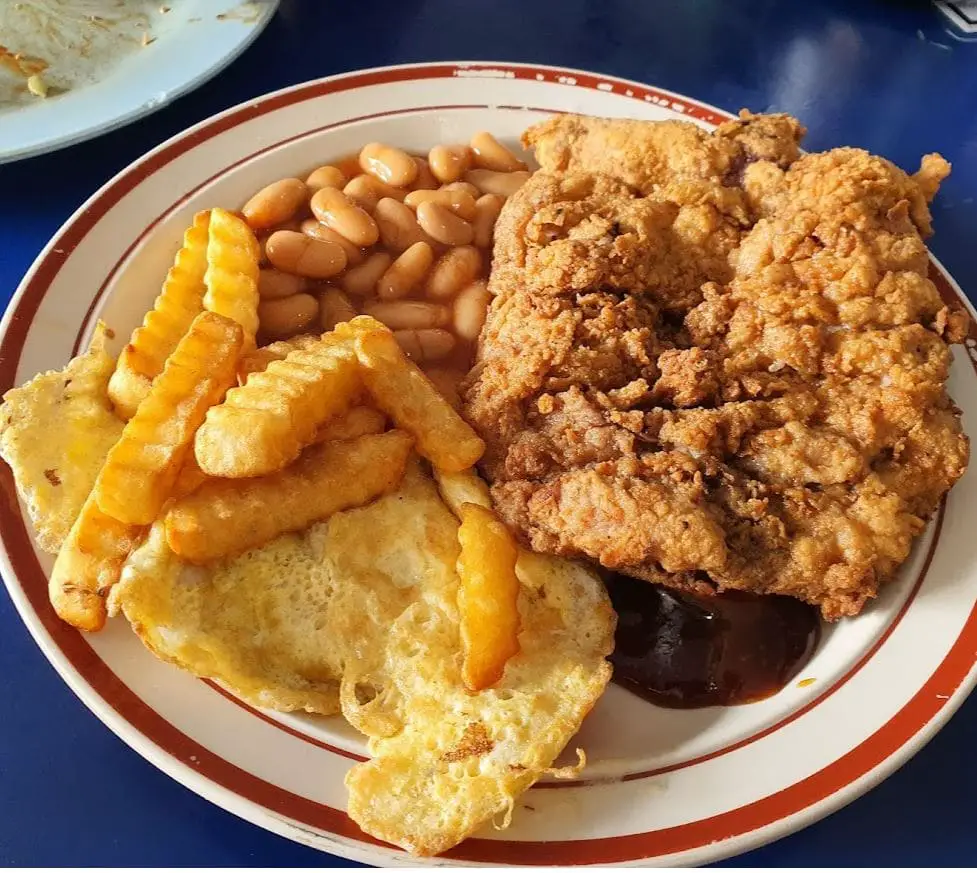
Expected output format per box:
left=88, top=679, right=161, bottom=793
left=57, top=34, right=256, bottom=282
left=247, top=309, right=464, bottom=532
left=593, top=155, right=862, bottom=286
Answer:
left=195, top=334, right=361, bottom=479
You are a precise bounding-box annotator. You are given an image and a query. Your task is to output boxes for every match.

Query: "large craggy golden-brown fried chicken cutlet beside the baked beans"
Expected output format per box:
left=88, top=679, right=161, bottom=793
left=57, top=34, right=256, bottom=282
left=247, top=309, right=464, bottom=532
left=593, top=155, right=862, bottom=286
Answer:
left=465, top=114, right=968, bottom=619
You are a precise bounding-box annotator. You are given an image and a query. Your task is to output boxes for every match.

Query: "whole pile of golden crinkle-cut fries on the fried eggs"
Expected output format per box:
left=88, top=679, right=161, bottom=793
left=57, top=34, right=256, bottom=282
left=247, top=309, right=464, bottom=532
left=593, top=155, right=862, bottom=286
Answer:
left=50, top=209, right=519, bottom=691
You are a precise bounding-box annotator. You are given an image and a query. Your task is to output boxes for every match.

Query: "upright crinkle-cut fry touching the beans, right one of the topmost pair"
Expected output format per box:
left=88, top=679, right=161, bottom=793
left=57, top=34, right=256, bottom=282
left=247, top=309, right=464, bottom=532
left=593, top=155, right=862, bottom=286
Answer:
left=204, top=209, right=261, bottom=349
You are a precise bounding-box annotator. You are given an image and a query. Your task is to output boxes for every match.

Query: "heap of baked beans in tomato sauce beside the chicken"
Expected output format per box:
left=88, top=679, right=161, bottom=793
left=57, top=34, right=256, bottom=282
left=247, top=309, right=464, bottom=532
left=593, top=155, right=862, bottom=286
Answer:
left=242, top=131, right=530, bottom=405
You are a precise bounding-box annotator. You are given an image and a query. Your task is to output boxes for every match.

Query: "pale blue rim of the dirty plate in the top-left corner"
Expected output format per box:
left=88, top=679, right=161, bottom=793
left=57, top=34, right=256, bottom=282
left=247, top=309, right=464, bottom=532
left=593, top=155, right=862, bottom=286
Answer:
left=0, top=0, right=279, bottom=164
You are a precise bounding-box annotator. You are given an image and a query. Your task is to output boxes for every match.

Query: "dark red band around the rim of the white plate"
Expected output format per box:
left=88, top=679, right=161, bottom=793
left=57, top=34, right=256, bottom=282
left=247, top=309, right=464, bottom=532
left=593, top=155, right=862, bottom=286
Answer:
left=0, top=63, right=977, bottom=865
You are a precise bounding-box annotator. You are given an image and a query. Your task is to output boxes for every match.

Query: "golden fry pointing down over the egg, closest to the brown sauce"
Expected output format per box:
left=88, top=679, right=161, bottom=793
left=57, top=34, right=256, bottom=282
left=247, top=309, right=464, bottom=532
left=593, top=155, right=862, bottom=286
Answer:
left=458, top=503, right=519, bottom=691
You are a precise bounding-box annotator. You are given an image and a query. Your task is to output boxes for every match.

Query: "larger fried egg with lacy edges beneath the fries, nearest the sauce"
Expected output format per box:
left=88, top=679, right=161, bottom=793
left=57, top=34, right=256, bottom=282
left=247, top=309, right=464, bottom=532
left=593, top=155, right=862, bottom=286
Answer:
left=109, top=462, right=615, bottom=854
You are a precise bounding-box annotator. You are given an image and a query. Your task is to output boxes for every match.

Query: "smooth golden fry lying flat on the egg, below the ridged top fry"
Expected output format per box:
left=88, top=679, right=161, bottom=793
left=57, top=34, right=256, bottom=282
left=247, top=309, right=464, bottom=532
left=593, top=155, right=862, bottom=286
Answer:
left=165, top=430, right=413, bottom=563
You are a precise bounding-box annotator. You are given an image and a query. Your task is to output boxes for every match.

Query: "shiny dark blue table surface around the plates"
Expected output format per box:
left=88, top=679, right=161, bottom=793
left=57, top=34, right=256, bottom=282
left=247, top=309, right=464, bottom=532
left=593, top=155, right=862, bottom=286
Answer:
left=0, top=0, right=977, bottom=866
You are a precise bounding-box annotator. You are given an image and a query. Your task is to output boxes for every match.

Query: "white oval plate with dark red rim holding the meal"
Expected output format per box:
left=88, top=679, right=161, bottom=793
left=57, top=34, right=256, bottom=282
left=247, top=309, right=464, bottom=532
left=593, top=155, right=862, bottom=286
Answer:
left=0, top=64, right=977, bottom=864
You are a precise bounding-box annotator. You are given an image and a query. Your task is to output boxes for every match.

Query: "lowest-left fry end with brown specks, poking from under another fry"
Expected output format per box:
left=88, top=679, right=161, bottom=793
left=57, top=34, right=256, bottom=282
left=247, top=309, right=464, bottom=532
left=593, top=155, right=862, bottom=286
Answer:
left=48, top=492, right=146, bottom=631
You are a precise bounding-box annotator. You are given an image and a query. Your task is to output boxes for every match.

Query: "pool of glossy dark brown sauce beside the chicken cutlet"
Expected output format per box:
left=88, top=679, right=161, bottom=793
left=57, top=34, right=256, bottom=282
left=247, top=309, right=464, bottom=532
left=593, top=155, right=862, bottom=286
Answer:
left=606, top=574, right=821, bottom=709
